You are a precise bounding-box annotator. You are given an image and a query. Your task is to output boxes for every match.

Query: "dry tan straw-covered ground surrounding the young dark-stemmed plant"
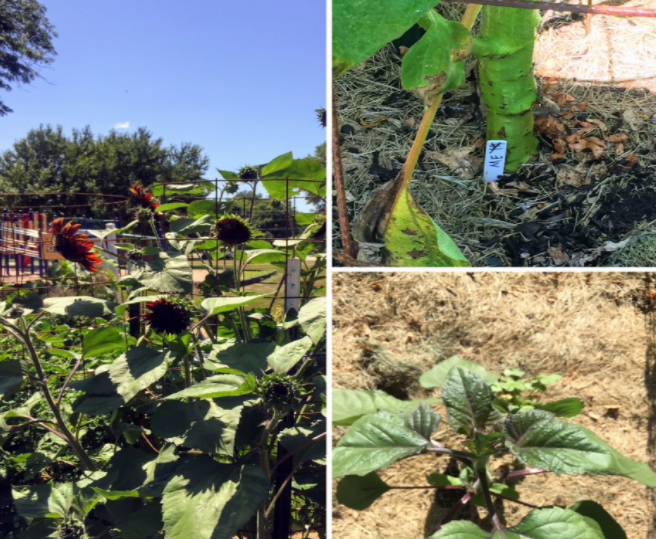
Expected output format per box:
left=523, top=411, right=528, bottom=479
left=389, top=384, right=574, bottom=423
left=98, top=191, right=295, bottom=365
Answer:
left=332, top=272, right=656, bottom=539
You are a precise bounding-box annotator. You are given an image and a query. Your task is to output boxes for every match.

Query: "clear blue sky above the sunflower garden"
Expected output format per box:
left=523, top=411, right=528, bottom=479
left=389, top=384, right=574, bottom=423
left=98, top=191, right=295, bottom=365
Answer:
left=0, top=0, right=326, bottom=178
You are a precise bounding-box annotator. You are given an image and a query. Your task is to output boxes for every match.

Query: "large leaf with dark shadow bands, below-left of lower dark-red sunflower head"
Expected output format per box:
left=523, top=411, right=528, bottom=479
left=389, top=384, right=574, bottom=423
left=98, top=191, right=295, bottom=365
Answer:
left=69, top=346, right=174, bottom=415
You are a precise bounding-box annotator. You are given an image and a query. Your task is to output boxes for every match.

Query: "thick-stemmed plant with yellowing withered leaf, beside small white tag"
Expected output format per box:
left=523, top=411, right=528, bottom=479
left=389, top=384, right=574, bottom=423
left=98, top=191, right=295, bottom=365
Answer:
left=333, top=0, right=539, bottom=267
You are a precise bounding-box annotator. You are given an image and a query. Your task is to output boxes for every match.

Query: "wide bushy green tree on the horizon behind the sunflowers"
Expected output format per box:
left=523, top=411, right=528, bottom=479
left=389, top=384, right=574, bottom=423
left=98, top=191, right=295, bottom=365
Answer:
left=0, top=126, right=209, bottom=218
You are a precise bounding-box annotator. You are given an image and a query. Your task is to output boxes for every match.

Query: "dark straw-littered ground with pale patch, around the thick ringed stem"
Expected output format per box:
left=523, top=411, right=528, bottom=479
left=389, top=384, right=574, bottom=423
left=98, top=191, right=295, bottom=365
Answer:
left=333, top=0, right=656, bottom=267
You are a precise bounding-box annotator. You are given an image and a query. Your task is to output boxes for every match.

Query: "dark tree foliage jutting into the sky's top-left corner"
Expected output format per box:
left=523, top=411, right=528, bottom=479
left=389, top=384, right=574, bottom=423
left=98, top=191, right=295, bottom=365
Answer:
left=0, top=0, right=57, bottom=116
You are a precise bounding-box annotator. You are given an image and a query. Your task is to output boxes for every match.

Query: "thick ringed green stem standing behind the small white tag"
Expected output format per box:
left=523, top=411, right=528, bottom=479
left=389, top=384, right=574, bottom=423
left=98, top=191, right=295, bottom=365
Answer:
left=472, top=2, right=540, bottom=172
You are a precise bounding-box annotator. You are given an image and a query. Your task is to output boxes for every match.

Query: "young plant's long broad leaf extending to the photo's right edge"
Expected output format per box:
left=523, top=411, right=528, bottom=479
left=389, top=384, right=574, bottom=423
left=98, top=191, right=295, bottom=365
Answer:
left=504, top=410, right=656, bottom=487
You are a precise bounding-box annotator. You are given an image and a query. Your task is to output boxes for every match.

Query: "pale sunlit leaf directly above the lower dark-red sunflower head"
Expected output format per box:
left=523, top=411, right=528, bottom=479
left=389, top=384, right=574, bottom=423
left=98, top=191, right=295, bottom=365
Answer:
left=130, top=252, right=193, bottom=301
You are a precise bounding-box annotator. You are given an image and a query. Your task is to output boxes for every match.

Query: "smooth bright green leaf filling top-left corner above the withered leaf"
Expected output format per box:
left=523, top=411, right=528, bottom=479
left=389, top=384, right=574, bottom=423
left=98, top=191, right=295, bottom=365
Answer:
left=333, top=0, right=437, bottom=77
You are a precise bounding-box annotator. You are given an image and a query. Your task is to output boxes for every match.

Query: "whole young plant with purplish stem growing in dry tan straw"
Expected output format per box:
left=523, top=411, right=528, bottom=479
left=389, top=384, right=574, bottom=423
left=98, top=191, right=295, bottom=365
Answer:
left=332, top=357, right=656, bottom=539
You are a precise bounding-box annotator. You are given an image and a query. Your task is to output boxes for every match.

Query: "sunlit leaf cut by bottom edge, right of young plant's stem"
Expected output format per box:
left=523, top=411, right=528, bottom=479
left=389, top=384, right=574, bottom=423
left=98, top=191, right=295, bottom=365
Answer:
left=512, top=507, right=608, bottom=539
